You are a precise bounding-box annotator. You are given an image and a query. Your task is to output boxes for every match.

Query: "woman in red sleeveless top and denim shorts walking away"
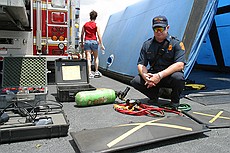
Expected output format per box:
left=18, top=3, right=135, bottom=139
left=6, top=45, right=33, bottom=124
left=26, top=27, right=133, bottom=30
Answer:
left=81, top=11, right=105, bottom=78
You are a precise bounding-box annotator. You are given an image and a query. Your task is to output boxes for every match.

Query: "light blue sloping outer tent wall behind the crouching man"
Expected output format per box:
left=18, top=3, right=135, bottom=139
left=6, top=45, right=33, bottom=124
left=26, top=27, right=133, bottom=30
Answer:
left=99, top=0, right=218, bottom=78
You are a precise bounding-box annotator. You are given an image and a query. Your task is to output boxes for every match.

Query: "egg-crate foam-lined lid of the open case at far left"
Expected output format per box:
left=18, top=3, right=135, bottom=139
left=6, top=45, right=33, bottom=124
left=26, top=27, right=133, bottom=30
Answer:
left=2, top=57, right=47, bottom=87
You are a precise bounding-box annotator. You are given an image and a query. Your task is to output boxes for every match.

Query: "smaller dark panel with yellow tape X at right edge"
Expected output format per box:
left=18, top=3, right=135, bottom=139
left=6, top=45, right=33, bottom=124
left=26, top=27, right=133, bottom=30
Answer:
left=187, top=109, right=230, bottom=128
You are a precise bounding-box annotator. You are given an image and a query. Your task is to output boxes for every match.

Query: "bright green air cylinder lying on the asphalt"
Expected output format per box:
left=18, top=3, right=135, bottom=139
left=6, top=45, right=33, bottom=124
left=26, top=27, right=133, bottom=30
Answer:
left=75, top=88, right=116, bottom=106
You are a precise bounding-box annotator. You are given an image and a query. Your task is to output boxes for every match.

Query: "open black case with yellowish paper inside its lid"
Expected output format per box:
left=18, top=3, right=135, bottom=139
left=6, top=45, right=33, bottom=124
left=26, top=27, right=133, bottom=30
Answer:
left=55, top=59, right=96, bottom=102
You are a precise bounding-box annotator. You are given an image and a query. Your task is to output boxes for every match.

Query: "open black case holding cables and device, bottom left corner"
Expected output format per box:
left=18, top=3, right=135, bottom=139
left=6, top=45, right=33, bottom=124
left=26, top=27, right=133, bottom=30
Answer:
left=0, top=110, right=69, bottom=144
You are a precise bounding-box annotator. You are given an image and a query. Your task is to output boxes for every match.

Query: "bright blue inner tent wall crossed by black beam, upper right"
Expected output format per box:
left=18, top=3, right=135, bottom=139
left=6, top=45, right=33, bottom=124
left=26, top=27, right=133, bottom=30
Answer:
left=197, top=0, right=230, bottom=70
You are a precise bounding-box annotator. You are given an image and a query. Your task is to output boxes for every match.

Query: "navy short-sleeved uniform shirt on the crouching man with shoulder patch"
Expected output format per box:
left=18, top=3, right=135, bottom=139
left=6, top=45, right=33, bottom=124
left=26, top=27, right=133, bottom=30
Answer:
left=137, top=35, right=186, bottom=72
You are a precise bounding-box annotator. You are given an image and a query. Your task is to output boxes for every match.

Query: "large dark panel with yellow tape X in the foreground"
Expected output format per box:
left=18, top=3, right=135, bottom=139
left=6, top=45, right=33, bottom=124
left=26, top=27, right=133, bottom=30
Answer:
left=70, top=116, right=209, bottom=153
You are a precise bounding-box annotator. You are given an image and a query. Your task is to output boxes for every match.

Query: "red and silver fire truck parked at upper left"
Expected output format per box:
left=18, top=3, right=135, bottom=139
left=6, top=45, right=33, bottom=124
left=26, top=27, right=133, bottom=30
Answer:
left=0, top=0, right=80, bottom=61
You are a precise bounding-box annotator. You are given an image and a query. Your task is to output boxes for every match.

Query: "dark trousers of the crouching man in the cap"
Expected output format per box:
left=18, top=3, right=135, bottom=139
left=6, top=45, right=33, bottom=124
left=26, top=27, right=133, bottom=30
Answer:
left=130, top=72, right=185, bottom=104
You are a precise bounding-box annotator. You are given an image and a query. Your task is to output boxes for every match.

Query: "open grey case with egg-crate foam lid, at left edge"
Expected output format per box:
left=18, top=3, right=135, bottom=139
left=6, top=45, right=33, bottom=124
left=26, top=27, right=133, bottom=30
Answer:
left=0, top=57, right=48, bottom=108
